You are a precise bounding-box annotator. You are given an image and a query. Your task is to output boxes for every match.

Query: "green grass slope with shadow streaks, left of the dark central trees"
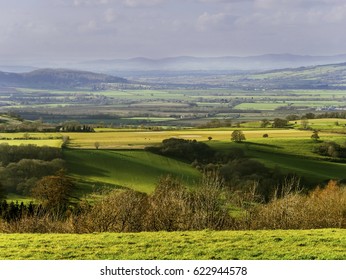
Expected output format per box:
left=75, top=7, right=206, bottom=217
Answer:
left=64, top=150, right=200, bottom=195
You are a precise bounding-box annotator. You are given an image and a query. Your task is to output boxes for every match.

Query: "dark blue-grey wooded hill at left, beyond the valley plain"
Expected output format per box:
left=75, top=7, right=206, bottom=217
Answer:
left=0, top=69, right=128, bottom=88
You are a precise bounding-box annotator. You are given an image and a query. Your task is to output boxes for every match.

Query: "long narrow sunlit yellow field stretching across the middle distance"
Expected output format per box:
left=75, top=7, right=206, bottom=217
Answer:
left=0, top=128, right=340, bottom=149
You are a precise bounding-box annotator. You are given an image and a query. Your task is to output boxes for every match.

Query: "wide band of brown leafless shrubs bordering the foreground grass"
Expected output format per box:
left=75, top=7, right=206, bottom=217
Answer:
left=0, top=176, right=346, bottom=233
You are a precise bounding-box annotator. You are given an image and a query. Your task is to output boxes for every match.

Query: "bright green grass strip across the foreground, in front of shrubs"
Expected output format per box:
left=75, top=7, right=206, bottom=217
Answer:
left=0, top=229, right=346, bottom=260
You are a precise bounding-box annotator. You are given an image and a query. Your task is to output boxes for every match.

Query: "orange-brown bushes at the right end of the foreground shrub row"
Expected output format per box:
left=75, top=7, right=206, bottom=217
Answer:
left=251, top=181, right=346, bottom=229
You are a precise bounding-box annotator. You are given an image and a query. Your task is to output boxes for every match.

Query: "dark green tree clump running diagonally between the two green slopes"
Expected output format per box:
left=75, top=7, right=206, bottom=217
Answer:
left=147, top=137, right=310, bottom=202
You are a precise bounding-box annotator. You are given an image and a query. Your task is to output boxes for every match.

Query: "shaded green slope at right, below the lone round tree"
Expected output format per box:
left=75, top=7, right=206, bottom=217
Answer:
left=210, top=136, right=346, bottom=184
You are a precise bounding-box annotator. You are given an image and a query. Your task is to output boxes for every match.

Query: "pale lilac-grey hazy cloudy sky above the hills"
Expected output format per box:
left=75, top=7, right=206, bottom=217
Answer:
left=0, top=0, right=346, bottom=61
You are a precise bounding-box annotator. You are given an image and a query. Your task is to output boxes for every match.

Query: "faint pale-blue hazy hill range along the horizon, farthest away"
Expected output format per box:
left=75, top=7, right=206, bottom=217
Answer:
left=76, top=54, right=346, bottom=73
